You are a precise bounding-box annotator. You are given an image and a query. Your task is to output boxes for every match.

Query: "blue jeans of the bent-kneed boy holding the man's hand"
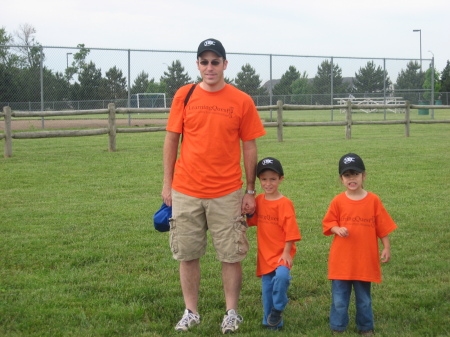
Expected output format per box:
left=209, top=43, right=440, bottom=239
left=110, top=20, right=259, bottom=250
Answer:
left=261, top=266, right=292, bottom=327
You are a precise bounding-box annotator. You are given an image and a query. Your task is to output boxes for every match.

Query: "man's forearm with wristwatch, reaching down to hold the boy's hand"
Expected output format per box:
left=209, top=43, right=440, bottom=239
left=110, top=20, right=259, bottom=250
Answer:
left=241, top=139, right=258, bottom=214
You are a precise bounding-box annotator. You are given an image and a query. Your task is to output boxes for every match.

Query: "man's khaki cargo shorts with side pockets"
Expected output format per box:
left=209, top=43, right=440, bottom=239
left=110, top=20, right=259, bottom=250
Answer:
left=170, top=189, right=249, bottom=263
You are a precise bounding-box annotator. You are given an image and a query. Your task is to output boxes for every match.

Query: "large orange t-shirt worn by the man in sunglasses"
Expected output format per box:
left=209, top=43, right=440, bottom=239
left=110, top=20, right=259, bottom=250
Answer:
left=166, top=84, right=266, bottom=199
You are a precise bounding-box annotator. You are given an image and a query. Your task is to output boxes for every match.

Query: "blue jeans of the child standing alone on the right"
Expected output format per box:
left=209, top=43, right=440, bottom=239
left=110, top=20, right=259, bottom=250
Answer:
left=330, top=280, right=373, bottom=331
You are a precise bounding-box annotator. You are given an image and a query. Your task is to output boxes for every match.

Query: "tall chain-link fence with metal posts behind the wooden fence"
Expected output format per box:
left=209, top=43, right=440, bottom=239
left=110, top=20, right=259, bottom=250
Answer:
left=0, top=46, right=444, bottom=117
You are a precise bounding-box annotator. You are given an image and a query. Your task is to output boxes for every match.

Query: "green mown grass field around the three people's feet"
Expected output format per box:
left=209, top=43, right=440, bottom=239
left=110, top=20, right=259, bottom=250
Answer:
left=0, top=124, right=450, bottom=337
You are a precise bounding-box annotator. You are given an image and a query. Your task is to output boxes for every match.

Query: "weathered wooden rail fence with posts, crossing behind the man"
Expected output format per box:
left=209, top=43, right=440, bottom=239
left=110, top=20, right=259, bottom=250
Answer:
left=0, top=100, right=450, bottom=158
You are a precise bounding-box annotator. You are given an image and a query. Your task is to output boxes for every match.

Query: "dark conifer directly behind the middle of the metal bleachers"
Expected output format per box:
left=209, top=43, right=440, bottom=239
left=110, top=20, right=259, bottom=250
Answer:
left=353, top=61, right=392, bottom=93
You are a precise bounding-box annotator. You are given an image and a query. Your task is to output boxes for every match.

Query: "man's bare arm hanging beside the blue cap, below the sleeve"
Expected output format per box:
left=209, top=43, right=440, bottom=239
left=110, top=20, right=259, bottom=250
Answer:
left=161, top=131, right=180, bottom=206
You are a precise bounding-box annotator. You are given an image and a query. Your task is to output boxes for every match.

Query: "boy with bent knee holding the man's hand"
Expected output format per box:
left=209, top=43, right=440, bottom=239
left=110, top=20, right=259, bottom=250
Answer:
left=247, top=157, right=301, bottom=330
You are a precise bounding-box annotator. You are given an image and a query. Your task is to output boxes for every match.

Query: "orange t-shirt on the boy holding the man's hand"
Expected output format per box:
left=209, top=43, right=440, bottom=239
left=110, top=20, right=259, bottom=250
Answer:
left=247, top=193, right=302, bottom=277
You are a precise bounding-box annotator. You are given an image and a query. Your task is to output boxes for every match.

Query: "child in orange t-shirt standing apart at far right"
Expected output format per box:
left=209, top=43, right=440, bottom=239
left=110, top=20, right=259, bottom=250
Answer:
left=322, top=153, right=397, bottom=336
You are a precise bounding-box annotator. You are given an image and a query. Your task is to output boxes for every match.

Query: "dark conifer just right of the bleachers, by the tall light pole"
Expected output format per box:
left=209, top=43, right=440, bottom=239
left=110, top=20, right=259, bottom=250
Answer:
left=395, top=61, right=425, bottom=103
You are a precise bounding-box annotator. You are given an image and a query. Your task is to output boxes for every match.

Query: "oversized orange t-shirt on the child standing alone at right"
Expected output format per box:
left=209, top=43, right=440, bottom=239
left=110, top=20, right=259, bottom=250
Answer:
left=322, top=192, right=397, bottom=283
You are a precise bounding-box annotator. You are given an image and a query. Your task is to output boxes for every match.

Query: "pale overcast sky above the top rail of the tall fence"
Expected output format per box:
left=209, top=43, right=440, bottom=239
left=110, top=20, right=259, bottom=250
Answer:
left=0, top=0, right=450, bottom=71
